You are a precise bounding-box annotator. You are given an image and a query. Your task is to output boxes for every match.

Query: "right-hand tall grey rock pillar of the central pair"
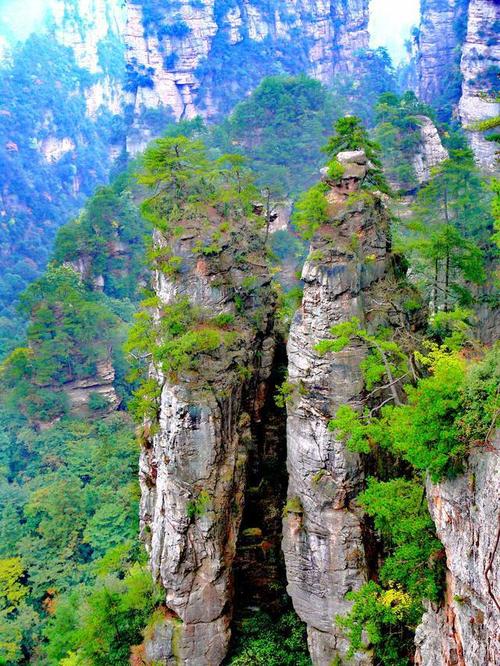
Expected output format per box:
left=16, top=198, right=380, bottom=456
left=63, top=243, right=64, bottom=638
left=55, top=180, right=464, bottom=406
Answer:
left=283, top=152, right=390, bottom=666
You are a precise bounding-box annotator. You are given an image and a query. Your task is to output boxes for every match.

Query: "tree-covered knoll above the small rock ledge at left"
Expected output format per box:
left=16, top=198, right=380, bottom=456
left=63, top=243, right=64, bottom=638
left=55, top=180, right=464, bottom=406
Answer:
left=0, top=265, right=125, bottom=421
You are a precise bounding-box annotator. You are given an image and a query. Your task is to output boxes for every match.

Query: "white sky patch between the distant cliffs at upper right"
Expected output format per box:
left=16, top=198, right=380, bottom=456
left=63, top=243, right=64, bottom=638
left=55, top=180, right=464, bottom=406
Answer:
left=370, top=0, right=420, bottom=64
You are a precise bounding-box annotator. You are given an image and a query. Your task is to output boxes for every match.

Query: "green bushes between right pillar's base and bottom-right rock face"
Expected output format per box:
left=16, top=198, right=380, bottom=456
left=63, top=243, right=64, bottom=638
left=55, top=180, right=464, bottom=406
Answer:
left=337, top=478, right=444, bottom=666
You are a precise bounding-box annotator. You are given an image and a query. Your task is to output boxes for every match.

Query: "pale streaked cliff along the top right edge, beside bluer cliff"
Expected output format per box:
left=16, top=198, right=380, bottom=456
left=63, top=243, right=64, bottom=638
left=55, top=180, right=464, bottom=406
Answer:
left=458, top=0, right=500, bottom=171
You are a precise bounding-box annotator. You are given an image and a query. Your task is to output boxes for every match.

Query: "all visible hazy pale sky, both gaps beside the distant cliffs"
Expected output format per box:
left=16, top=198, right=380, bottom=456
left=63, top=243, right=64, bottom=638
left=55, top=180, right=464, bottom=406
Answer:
left=0, top=0, right=419, bottom=63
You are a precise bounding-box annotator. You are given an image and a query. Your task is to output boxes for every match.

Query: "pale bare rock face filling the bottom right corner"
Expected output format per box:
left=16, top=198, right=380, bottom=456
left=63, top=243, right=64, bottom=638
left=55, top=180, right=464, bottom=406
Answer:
left=416, top=436, right=500, bottom=666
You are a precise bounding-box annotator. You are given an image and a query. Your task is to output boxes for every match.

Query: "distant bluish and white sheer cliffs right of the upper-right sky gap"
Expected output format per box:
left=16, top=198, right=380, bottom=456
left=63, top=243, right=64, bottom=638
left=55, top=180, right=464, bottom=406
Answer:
left=417, top=0, right=500, bottom=170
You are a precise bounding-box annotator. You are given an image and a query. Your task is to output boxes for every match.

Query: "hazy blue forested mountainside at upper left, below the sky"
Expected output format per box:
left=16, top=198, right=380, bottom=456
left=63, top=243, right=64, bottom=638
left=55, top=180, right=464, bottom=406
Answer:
left=0, top=34, right=123, bottom=317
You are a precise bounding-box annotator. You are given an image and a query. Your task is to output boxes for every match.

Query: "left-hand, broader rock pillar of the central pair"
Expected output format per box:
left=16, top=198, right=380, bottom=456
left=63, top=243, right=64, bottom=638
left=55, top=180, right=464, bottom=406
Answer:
left=140, top=206, right=274, bottom=666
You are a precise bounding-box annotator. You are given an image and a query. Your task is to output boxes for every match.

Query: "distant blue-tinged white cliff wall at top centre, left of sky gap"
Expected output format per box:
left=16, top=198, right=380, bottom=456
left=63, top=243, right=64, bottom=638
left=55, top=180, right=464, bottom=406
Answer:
left=124, top=0, right=368, bottom=147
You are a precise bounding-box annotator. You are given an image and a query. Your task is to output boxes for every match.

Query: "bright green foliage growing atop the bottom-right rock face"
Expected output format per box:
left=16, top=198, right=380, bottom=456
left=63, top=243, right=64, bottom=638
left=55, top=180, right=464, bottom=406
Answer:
left=331, top=347, right=499, bottom=481
